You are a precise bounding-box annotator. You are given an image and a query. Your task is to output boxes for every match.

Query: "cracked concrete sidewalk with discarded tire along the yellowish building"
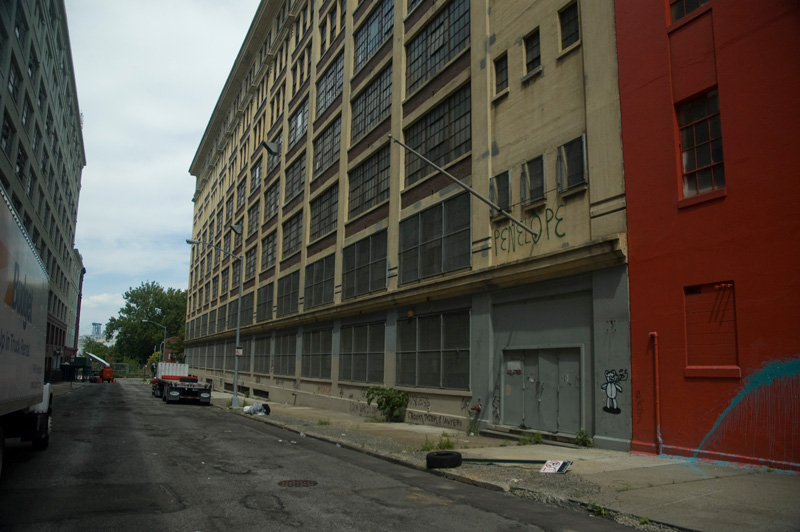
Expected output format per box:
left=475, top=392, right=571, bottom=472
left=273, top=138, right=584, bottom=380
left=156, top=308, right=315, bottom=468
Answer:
left=48, top=383, right=800, bottom=532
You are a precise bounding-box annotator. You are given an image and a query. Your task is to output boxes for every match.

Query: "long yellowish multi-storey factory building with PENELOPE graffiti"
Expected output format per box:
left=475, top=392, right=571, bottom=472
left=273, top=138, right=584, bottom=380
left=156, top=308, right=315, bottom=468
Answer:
left=185, top=0, right=632, bottom=450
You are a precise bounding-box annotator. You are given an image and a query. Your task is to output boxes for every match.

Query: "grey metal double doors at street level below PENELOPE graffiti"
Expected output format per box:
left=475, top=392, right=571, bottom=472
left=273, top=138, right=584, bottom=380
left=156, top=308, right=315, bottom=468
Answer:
left=501, top=347, right=581, bottom=434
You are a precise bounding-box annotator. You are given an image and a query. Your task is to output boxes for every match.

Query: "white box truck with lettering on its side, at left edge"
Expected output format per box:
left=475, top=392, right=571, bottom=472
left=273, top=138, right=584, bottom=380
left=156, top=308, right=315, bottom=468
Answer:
left=0, top=186, right=52, bottom=471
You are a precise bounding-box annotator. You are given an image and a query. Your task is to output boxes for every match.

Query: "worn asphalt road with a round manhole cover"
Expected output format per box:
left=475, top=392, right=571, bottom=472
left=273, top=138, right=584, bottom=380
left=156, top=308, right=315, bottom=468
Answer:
left=0, top=380, right=630, bottom=532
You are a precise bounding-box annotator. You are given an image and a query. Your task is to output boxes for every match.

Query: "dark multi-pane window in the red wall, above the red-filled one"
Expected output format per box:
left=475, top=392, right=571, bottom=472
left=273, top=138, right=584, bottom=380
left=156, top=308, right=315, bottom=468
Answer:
left=678, top=91, right=725, bottom=198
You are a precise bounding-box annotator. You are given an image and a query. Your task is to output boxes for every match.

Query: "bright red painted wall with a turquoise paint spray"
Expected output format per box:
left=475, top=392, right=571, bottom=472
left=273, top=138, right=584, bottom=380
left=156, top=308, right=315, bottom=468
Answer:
left=615, top=0, right=800, bottom=469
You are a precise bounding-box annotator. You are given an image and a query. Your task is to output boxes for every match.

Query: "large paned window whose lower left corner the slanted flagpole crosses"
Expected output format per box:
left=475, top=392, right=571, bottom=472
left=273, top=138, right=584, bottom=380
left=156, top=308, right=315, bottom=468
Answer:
left=405, top=84, right=472, bottom=186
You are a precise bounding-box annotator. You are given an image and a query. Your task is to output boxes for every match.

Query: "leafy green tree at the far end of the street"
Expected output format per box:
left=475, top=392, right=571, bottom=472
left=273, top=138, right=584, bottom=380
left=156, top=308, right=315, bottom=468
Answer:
left=106, top=281, right=186, bottom=364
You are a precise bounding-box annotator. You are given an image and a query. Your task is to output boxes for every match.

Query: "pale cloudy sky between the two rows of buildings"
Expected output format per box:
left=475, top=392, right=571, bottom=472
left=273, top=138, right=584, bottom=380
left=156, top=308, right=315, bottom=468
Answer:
left=66, top=0, right=258, bottom=335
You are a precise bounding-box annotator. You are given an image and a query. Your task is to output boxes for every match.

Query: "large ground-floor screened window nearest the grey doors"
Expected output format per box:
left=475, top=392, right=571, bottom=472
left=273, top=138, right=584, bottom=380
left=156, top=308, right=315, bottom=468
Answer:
left=397, top=311, right=470, bottom=390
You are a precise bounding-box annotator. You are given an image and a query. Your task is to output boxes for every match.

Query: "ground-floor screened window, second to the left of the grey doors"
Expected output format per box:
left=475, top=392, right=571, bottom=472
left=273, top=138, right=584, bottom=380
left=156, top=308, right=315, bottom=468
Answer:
left=339, top=322, right=386, bottom=383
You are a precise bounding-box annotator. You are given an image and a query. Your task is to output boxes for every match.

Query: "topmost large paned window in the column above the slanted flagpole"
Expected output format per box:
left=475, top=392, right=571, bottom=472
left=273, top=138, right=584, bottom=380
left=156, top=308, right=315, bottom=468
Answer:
left=406, top=0, right=469, bottom=93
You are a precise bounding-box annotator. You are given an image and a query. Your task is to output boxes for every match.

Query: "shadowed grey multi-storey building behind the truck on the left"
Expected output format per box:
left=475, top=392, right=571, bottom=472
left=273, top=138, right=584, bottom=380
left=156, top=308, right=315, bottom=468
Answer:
left=0, top=0, right=86, bottom=378
